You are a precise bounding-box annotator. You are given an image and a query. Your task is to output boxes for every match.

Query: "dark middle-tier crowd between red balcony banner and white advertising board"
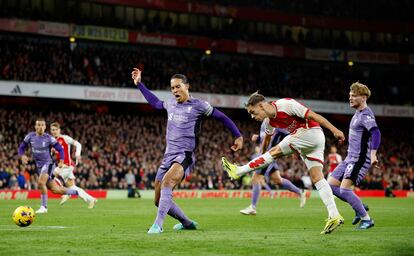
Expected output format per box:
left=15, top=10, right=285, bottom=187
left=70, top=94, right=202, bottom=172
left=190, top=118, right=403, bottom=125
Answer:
left=0, top=34, right=414, bottom=105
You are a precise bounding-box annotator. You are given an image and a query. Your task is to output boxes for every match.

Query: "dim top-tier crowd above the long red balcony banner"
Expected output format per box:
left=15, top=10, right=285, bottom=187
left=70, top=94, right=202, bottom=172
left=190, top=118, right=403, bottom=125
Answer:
left=0, top=0, right=414, bottom=53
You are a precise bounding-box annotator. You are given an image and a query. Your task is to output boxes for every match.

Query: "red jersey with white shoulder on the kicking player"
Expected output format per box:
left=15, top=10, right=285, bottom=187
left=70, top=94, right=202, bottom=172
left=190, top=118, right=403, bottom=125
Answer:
left=266, top=98, right=320, bottom=135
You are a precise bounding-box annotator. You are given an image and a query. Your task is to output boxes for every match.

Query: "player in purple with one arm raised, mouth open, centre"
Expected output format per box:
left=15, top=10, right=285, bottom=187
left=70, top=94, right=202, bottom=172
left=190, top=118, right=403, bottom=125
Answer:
left=132, top=68, right=243, bottom=234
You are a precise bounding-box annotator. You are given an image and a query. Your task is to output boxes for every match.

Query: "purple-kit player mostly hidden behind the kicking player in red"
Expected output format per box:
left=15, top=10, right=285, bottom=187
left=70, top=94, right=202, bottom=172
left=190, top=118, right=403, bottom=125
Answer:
left=240, top=122, right=306, bottom=215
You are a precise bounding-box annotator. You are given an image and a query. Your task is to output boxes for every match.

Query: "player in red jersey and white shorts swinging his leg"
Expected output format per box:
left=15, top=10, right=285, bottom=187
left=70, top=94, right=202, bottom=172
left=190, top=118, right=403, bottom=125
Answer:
left=222, top=93, right=345, bottom=234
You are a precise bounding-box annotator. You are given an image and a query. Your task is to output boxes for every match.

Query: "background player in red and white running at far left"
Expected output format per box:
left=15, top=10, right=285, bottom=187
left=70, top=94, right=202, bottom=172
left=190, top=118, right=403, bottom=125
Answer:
left=50, top=122, right=97, bottom=209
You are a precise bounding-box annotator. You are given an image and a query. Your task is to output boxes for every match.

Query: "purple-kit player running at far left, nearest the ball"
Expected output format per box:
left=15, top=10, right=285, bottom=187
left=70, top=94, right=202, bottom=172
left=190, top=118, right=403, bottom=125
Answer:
left=19, top=118, right=78, bottom=213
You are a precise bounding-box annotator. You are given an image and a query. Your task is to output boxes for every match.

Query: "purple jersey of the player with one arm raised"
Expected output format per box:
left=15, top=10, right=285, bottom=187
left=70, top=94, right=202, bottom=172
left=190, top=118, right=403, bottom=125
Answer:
left=163, top=97, right=213, bottom=155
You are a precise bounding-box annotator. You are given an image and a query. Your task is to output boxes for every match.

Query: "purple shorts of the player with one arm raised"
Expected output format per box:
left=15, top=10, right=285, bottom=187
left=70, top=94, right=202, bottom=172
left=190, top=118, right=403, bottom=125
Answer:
left=155, top=151, right=195, bottom=181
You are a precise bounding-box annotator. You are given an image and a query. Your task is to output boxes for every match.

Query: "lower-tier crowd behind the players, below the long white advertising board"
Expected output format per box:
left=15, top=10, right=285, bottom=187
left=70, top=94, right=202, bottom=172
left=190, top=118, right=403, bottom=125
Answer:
left=0, top=108, right=414, bottom=190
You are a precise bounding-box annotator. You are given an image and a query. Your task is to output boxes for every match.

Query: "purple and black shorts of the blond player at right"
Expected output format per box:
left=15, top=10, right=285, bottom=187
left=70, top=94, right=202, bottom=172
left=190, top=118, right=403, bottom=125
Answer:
left=331, top=157, right=371, bottom=185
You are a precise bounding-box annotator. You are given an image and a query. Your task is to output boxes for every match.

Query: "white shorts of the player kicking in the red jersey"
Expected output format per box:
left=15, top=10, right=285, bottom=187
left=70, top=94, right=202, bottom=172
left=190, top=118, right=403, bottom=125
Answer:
left=278, top=127, right=325, bottom=169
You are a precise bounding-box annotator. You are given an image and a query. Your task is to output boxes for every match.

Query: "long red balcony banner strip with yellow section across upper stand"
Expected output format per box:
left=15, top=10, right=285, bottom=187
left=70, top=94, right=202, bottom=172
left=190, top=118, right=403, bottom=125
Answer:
left=0, top=19, right=414, bottom=65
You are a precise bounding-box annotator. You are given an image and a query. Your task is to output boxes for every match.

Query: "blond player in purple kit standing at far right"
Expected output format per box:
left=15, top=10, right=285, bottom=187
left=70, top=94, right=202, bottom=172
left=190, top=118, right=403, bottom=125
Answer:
left=328, top=82, right=381, bottom=229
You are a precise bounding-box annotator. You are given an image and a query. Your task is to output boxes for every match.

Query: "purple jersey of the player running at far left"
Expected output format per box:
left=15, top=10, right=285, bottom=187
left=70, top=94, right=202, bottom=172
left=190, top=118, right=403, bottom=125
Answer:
left=24, top=132, right=57, bottom=168
